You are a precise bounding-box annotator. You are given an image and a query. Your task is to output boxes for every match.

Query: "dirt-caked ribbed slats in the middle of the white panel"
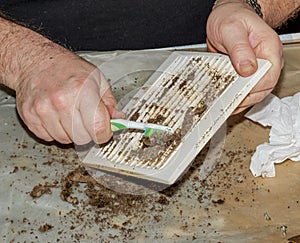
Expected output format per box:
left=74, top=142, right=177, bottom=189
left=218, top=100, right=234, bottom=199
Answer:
left=98, top=54, right=237, bottom=169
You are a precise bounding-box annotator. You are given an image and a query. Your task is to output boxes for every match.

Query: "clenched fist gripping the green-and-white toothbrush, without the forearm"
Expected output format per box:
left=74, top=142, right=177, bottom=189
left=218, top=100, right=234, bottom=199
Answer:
left=16, top=53, right=120, bottom=144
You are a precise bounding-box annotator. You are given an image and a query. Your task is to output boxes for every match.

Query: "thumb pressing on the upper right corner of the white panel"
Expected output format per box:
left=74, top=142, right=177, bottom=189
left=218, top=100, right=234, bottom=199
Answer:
left=223, top=24, right=257, bottom=77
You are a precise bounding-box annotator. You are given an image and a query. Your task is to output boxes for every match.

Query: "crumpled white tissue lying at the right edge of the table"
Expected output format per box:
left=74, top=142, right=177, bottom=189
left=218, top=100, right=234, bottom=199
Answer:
left=245, top=93, right=300, bottom=177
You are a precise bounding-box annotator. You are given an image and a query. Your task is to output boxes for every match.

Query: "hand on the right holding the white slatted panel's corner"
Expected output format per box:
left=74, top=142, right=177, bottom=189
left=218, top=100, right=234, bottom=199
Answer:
left=207, top=0, right=284, bottom=113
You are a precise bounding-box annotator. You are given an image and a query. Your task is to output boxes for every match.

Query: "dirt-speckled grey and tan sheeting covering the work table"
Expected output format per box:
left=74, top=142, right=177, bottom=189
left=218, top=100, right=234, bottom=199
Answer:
left=0, top=44, right=300, bottom=242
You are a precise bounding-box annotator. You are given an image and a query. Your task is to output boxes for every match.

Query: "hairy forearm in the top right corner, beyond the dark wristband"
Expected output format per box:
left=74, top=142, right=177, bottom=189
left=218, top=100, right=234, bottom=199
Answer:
left=258, top=0, right=300, bottom=28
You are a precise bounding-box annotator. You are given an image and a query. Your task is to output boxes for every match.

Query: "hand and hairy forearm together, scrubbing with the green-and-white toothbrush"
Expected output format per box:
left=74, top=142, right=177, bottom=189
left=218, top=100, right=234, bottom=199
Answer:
left=0, top=18, right=124, bottom=145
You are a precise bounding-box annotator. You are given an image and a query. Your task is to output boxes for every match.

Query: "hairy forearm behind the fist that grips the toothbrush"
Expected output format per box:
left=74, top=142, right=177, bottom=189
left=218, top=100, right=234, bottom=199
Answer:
left=0, top=17, right=68, bottom=90
